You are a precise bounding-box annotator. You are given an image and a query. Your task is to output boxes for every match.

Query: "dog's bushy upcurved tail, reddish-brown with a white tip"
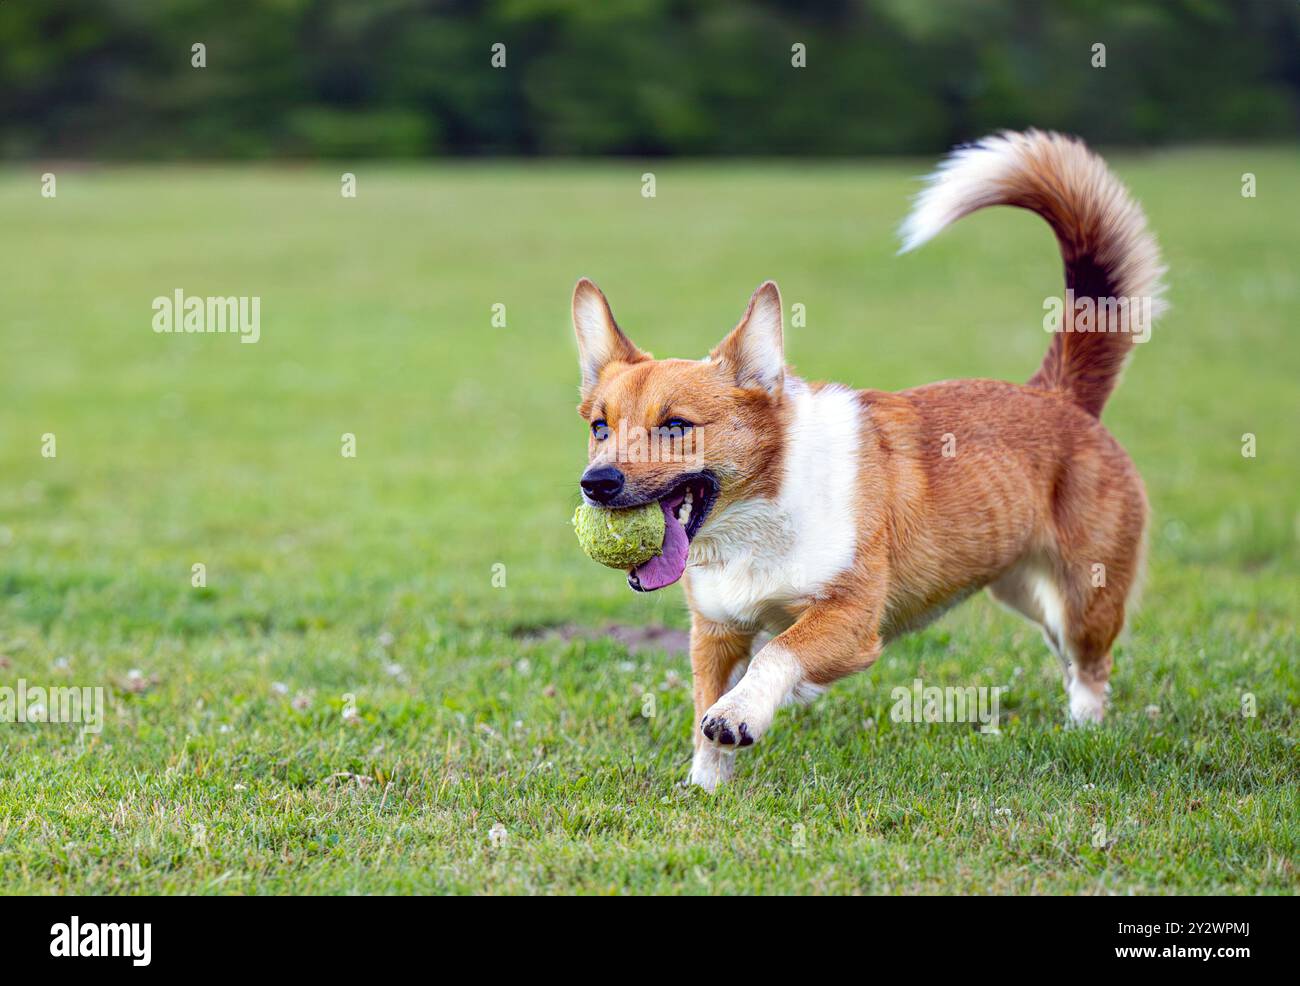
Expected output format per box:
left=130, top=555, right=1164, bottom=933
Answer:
left=900, top=130, right=1165, bottom=418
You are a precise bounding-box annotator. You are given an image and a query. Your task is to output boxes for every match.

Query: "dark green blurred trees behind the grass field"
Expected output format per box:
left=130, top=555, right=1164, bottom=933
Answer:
left=0, top=0, right=1300, bottom=160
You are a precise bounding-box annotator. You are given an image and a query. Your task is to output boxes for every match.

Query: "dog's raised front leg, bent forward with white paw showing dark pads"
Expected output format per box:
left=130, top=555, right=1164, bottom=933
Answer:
left=697, top=600, right=880, bottom=756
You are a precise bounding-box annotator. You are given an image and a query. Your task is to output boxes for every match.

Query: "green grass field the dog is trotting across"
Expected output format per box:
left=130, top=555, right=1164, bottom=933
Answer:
left=0, top=148, right=1300, bottom=894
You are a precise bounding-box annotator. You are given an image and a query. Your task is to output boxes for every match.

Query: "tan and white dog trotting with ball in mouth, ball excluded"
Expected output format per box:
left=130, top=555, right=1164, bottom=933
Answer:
left=573, top=131, right=1164, bottom=790
